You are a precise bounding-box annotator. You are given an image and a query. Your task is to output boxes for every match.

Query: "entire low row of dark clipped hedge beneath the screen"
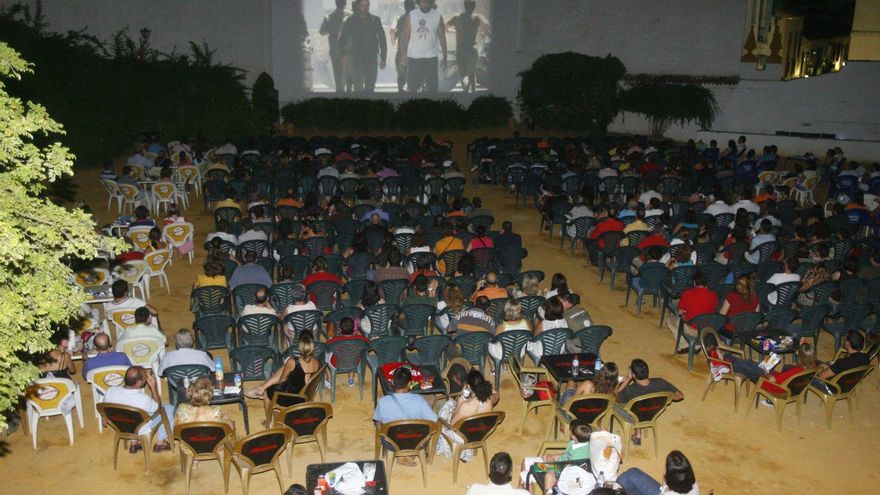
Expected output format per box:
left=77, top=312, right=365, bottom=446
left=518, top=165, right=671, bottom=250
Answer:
left=281, top=96, right=513, bottom=131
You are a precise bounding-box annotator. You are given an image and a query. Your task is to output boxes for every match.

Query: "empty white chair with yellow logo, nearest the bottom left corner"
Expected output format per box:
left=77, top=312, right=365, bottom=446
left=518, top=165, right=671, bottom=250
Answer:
left=25, top=378, right=84, bottom=450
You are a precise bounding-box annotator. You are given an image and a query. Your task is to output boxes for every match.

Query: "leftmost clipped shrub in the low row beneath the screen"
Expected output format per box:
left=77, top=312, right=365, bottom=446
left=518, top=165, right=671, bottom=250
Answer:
left=281, top=98, right=394, bottom=131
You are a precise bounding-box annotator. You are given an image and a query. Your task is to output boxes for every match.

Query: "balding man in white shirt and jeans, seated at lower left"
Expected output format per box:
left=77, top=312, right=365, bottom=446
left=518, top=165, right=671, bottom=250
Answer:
left=104, top=366, right=174, bottom=454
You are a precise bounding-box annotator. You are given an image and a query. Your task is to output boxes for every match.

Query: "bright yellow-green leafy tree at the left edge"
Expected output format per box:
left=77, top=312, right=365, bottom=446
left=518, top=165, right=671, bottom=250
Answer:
left=0, top=42, right=121, bottom=427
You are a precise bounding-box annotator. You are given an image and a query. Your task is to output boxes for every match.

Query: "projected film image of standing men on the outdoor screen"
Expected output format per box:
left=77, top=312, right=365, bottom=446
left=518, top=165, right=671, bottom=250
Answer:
left=303, top=0, right=492, bottom=96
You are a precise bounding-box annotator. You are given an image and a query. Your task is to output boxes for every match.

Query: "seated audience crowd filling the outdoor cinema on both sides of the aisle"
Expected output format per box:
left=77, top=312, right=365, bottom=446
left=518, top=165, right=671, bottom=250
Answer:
left=22, top=132, right=880, bottom=495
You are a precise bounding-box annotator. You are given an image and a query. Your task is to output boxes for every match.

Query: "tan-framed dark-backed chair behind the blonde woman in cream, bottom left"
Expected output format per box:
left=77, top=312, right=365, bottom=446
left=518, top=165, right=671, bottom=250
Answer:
left=174, top=421, right=235, bottom=495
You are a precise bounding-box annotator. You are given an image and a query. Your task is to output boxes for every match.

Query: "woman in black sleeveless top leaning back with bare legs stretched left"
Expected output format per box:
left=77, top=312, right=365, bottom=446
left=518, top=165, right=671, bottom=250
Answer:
left=245, top=331, right=321, bottom=417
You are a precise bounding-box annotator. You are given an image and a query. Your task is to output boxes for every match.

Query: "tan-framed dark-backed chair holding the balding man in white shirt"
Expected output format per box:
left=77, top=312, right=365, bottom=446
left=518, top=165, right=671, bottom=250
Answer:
left=97, top=402, right=172, bottom=472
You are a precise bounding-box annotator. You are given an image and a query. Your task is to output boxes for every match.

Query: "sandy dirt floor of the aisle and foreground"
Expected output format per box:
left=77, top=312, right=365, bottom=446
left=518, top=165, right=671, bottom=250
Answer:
left=0, top=130, right=880, bottom=495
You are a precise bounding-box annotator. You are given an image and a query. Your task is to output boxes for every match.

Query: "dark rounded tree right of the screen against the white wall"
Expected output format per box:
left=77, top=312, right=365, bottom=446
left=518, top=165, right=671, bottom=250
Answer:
left=517, top=52, right=626, bottom=131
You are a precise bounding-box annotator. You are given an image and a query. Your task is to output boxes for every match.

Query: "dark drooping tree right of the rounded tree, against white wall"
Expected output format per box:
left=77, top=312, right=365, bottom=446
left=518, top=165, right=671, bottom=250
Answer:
left=620, top=84, right=718, bottom=136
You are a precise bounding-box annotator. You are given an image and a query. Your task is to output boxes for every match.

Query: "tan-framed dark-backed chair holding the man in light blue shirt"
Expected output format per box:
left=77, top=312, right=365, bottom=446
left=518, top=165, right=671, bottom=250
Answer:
left=374, top=419, right=438, bottom=488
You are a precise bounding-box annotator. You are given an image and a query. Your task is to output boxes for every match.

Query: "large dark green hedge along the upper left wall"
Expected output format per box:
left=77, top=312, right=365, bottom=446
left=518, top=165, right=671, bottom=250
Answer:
left=0, top=6, right=261, bottom=166
